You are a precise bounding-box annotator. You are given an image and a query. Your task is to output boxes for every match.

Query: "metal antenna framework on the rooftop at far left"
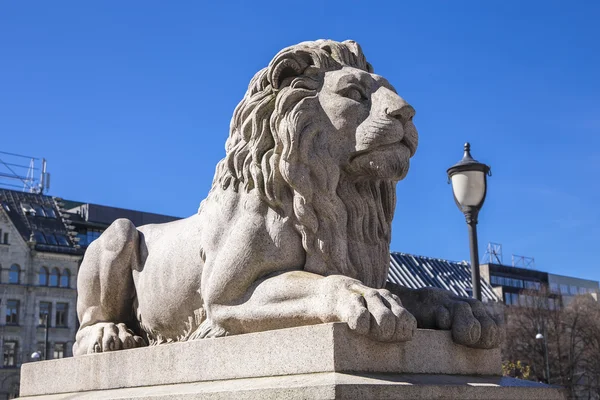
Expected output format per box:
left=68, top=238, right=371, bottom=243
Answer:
left=0, top=151, right=50, bottom=194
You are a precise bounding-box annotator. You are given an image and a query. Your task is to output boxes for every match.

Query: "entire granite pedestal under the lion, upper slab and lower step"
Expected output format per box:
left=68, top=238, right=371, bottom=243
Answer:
left=21, top=323, right=564, bottom=400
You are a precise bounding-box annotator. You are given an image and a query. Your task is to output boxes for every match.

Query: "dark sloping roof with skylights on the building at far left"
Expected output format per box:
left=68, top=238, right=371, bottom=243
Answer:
left=0, top=189, right=83, bottom=254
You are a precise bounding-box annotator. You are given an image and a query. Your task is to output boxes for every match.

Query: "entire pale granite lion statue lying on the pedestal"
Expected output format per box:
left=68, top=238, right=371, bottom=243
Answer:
left=73, top=40, right=501, bottom=355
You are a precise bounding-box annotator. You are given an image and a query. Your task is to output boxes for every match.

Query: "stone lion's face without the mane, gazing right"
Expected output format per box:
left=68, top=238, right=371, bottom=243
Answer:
left=318, top=66, right=418, bottom=181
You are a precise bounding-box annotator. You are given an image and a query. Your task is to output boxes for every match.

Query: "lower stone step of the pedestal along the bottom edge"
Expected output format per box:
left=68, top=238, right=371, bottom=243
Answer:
left=21, top=372, right=565, bottom=400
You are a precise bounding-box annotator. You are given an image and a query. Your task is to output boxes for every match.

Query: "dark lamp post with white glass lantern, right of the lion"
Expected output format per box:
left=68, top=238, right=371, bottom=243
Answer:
left=447, top=143, right=491, bottom=300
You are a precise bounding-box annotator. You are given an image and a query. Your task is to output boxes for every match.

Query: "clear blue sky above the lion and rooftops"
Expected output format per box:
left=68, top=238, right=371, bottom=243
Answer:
left=0, top=0, right=600, bottom=280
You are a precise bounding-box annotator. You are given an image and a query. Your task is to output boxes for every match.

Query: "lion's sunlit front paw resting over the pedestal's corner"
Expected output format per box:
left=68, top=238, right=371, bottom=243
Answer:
left=326, top=276, right=417, bottom=342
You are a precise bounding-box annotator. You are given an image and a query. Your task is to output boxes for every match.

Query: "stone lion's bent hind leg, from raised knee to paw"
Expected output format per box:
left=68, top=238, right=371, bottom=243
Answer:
left=73, top=219, right=146, bottom=355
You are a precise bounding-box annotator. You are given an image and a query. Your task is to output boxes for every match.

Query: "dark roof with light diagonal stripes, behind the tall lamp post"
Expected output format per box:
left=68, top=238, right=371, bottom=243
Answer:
left=388, top=252, right=500, bottom=301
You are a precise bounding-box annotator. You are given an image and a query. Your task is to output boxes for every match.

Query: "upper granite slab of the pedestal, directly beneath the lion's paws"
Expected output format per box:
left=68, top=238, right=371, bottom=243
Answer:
left=21, top=323, right=501, bottom=396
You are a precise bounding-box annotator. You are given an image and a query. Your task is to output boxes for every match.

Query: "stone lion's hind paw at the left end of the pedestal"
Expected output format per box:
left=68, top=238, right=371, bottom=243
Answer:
left=73, top=322, right=146, bottom=355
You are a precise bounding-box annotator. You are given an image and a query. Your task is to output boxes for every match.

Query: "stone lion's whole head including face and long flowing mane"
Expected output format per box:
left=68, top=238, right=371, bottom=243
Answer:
left=206, top=40, right=417, bottom=287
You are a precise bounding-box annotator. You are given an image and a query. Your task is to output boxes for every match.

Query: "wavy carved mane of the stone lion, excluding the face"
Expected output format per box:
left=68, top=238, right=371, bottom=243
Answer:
left=205, top=40, right=396, bottom=288
